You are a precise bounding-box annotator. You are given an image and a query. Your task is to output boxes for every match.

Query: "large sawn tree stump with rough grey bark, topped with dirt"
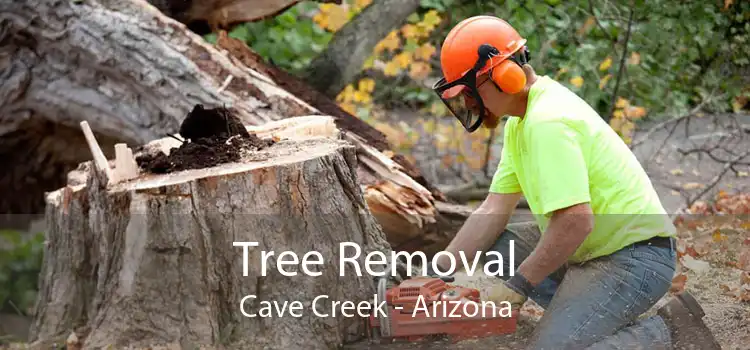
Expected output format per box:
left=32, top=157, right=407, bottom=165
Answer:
left=31, top=121, right=390, bottom=349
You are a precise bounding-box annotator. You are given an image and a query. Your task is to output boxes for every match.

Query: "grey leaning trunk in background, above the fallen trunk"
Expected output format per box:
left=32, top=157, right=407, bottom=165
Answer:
left=305, top=0, right=426, bottom=97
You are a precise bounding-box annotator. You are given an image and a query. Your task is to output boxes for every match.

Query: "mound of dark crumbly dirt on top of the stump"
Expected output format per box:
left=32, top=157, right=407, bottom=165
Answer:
left=136, top=104, right=274, bottom=174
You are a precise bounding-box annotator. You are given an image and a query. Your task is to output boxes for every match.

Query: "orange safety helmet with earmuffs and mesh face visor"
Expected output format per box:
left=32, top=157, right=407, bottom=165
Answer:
left=433, top=16, right=529, bottom=132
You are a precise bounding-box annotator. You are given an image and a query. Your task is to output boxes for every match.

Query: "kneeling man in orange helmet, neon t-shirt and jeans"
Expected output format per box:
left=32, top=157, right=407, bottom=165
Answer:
left=432, top=16, right=720, bottom=349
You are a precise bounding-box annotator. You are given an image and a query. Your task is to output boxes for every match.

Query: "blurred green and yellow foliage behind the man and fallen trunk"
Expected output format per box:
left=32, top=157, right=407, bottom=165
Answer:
left=207, top=0, right=750, bottom=182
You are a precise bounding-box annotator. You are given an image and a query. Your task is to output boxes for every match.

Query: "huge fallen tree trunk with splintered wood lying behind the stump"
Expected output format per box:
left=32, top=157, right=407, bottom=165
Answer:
left=0, top=0, right=470, bottom=256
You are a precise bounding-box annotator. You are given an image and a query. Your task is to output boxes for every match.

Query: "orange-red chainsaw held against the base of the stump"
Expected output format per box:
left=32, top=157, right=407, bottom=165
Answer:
left=368, top=277, right=518, bottom=343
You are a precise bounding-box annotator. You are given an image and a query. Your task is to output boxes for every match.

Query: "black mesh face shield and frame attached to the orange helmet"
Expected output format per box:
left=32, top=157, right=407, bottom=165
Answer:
left=432, top=44, right=529, bottom=133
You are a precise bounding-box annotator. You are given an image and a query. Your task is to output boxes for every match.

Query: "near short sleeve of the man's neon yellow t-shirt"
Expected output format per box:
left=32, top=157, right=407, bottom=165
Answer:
left=528, top=121, right=591, bottom=216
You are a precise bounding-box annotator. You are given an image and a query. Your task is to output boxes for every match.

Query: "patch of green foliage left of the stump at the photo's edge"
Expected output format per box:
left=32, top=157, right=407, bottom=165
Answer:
left=0, top=230, right=44, bottom=313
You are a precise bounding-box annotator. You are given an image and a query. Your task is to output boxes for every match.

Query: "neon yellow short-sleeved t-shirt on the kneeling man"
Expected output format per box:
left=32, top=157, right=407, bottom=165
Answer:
left=490, top=76, right=676, bottom=262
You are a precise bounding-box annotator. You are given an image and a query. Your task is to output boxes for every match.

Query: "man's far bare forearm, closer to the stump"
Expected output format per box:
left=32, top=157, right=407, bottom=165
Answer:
left=437, top=194, right=520, bottom=271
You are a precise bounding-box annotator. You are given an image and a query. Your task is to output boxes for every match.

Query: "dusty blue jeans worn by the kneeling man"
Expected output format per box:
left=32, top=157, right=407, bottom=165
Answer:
left=490, top=223, right=676, bottom=349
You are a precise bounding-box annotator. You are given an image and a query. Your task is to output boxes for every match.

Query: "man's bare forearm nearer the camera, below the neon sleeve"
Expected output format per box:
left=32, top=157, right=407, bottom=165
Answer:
left=518, top=204, right=593, bottom=286
